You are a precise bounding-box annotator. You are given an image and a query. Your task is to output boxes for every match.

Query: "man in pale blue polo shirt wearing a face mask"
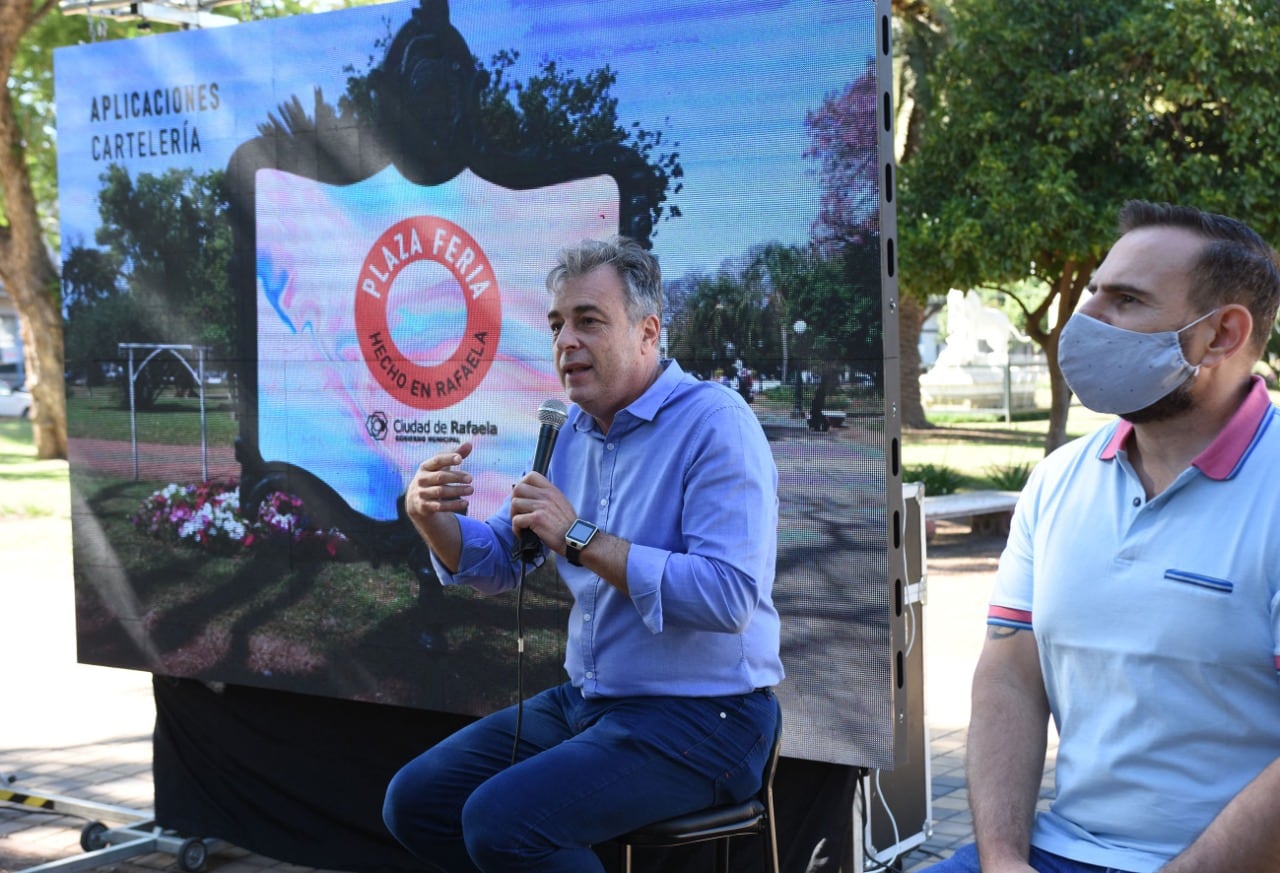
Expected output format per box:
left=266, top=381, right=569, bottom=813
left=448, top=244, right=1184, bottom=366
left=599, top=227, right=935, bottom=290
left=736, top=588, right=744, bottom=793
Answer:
left=931, top=201, right=1280, bottom=873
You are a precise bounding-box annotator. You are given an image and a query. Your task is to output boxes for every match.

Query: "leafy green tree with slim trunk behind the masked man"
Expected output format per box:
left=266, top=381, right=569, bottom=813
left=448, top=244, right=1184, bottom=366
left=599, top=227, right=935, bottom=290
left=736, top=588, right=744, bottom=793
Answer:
left=899, top=0, right=1280, bottom=440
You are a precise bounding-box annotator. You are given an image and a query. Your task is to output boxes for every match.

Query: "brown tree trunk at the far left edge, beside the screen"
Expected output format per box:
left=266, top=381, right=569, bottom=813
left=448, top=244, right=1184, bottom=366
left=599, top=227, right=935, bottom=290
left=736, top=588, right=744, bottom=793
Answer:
left=0, top=0, right=67, bottom=460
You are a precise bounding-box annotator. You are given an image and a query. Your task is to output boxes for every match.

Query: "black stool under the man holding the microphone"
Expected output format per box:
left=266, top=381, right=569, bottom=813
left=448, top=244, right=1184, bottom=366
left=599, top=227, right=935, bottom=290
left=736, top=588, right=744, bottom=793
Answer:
left=618, top=717, right=782, bottom=873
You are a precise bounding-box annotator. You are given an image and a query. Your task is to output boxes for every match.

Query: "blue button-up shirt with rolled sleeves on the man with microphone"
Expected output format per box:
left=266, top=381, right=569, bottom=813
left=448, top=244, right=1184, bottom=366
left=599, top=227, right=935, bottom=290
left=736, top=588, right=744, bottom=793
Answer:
left=435, top=361, right=783, bottom=698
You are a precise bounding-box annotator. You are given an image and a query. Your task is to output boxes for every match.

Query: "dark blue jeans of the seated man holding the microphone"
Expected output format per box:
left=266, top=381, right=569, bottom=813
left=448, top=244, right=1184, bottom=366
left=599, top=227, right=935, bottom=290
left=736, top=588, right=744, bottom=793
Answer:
left=383, top=684, right=780, bottom=873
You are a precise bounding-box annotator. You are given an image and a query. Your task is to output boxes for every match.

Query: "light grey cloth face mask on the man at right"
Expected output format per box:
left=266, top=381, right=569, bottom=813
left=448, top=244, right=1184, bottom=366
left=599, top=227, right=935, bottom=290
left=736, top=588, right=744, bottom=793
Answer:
left=1057, top=308, right=1217, bottom=415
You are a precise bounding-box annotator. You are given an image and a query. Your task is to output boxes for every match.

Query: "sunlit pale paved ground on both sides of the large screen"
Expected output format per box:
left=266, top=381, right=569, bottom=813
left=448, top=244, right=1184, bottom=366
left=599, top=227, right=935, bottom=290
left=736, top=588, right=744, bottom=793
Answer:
left=0, top=518, right=1052, bottom=873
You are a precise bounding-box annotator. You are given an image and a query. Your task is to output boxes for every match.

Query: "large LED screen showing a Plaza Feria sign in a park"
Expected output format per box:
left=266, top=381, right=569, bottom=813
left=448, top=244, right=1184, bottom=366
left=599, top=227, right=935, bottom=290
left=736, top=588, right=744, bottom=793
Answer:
left=55, top=0, right=902, bottom=767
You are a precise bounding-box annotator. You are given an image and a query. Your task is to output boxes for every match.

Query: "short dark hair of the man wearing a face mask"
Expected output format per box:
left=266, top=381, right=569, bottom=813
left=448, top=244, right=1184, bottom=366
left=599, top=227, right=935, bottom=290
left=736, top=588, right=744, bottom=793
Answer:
left=1120, top=200, right=1280, bottom=355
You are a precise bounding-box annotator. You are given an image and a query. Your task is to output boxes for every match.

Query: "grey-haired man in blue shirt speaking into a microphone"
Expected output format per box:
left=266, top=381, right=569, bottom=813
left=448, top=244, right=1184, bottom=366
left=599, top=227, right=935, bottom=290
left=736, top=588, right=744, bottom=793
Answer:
left=384, top=237, right=782, bottom=873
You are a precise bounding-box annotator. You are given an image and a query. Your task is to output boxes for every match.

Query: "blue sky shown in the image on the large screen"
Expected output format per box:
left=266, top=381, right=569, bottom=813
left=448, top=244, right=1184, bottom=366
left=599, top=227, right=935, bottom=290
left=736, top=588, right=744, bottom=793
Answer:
left=55, top=0, right=876, bottom=279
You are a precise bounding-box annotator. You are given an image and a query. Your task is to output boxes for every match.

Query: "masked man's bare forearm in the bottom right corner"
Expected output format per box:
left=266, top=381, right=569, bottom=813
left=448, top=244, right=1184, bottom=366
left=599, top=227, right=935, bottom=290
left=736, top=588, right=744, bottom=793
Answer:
left=1160, top=759, right=1280, bottom=873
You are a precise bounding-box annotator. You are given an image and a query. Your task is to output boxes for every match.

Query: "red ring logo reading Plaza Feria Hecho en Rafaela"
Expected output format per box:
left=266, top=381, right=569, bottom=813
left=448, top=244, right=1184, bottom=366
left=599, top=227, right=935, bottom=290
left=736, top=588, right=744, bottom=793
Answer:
left=356, top=215, right=502, bottom=410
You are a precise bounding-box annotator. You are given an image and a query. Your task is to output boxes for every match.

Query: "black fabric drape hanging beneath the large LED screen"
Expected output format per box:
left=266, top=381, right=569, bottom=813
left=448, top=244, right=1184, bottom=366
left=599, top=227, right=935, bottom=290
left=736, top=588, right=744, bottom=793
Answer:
left=154, top=676, right=859, bottom=873
